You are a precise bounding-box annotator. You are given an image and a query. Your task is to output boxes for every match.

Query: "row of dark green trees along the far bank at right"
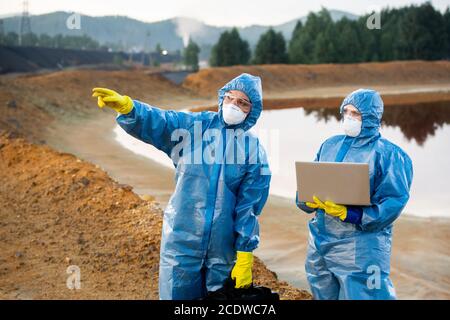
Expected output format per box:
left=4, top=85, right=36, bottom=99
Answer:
left=209, top=2, right=450, bottom=66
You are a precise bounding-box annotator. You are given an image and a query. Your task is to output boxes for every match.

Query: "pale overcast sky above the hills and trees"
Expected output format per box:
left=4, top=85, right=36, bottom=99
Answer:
left=0, top=0, right=450, bottom=26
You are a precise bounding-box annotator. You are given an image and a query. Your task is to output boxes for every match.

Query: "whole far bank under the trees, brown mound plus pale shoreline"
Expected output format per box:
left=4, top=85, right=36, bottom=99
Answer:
left=183, top=61, right=450, bottom=111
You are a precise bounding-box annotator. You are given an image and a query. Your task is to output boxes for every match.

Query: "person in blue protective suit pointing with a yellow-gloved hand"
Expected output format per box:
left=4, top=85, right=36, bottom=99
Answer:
left=93, top=74, right=271, bottom=299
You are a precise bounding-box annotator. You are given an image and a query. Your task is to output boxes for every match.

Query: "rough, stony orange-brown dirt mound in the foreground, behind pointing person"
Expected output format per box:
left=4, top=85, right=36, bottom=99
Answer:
left=0, top=135, right=310, bottom=299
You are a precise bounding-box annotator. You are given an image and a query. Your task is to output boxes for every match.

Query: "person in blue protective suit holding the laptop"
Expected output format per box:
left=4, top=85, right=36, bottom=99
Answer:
left=296, top=89, right=413, bottom=299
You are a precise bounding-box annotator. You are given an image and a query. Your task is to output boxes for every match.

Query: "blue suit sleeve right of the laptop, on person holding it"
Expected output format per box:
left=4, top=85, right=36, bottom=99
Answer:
left=360, top=151, right=413, bottom=231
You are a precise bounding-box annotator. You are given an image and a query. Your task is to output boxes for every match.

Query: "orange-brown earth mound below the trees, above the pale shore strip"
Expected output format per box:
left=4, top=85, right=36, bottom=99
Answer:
left=183, top=61, right=450, bottom=96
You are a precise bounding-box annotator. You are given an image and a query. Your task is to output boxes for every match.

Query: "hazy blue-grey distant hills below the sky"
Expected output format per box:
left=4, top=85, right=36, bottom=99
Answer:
left=3, top=10, right=357, bottom=56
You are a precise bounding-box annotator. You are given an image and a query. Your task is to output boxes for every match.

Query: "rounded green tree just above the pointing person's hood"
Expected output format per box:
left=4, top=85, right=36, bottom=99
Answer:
left=209, top=28, right=251, bottom=66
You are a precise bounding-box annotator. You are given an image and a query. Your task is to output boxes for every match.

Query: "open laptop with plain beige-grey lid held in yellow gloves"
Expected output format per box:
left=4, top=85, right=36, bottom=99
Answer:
left=295, top=161, right=371, bottom=206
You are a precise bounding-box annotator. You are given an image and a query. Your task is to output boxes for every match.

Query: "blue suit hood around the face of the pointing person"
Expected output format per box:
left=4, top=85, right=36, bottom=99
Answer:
left=218, top=73, right=262, bottom=131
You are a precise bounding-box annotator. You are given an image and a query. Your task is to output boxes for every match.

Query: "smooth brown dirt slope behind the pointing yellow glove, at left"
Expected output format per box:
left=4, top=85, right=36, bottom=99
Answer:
left=0, top=69, right=202, bottom=142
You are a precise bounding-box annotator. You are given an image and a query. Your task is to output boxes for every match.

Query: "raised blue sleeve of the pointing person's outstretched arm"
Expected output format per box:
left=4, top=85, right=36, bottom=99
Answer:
left=116, top=100, right=199, bottom=157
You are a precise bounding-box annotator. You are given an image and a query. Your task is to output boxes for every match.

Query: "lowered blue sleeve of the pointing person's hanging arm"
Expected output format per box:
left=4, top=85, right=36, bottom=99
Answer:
left=234, top=151, right=271, bottom=252
